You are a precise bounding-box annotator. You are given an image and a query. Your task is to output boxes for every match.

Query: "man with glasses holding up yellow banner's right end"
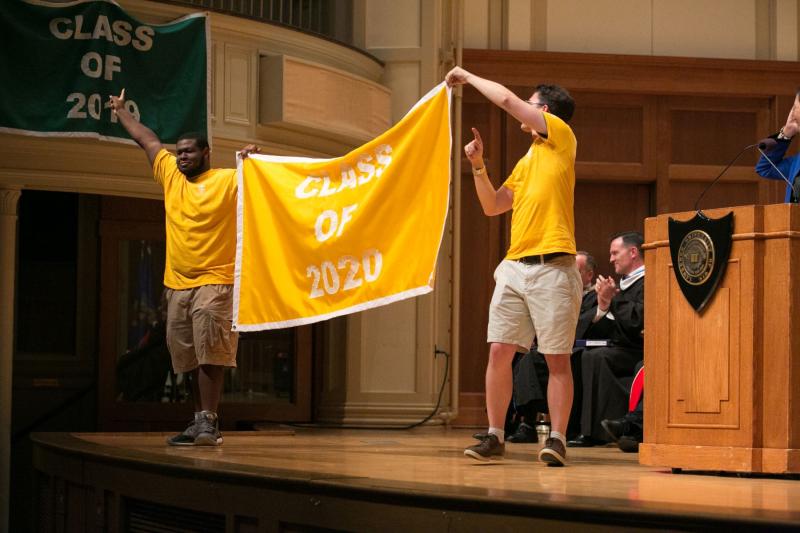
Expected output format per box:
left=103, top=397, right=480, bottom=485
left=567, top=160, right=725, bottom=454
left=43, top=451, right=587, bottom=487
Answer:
left=445, top=67, right=583, bottom=466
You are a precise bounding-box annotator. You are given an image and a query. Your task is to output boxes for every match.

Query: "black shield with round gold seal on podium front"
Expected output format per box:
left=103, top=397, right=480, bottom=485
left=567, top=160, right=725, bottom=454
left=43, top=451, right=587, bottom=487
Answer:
left=669, top=211, right=733, bottom=313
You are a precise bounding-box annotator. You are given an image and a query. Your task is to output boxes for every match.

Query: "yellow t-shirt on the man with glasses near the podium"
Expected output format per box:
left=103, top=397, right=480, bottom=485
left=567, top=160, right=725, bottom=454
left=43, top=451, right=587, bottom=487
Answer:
left=503, top=113, right=578, bottom=259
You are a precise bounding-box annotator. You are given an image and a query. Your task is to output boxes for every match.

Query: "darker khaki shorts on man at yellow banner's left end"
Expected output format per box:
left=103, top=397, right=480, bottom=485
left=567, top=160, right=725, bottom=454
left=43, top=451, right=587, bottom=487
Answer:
left=167, top=285, right=239, bottom=372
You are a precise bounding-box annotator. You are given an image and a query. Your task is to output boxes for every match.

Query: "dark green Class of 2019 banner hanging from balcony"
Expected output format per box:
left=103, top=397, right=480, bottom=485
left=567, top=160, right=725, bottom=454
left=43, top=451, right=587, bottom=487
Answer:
left=0, top=0, right=209, bottom=144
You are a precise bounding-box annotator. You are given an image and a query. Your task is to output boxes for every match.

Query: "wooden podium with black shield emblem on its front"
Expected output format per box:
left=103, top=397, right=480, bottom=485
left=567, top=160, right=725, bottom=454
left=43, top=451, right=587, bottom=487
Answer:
left=639, top=204, right=800, bottom=473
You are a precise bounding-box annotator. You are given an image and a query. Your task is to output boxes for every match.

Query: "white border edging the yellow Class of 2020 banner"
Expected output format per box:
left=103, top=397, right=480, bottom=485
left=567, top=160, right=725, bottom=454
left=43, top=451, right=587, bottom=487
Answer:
left=231, top=82, right=453, bottom=331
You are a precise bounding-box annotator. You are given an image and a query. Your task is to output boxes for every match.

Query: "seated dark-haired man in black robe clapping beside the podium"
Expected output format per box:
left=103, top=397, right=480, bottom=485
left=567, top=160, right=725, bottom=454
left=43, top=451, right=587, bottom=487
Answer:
left=567, top=232, right=644, bottom=447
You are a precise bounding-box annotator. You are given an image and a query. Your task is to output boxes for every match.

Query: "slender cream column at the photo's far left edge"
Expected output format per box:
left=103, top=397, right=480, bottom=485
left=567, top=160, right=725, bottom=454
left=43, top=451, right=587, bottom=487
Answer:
left=0, top=189, right=20, bottom=531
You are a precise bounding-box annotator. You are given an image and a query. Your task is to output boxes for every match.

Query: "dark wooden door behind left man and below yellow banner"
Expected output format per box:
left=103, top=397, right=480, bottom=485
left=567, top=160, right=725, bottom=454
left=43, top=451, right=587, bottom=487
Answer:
left=99, top=198, right=312, bottom=431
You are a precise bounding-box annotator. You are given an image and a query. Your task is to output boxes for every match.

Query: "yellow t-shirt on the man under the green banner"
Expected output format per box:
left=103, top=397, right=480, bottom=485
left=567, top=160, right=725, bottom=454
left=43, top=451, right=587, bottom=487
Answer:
left=153, top=149, right=237, bottom=290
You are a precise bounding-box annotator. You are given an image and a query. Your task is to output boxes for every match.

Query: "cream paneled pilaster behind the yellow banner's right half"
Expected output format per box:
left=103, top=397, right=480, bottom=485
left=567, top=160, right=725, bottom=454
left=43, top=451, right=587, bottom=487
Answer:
left=317, top=0, right=452, bottom=426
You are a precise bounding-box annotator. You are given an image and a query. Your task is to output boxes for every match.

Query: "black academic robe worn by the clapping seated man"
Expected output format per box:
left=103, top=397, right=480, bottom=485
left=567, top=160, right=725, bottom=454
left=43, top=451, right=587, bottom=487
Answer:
left=580, top=277, right=644, bottom=440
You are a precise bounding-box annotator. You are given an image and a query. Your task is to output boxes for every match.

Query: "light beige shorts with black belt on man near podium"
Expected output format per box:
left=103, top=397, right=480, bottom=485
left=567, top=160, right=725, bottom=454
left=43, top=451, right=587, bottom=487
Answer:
left=487, top=255, right=583, bottom=354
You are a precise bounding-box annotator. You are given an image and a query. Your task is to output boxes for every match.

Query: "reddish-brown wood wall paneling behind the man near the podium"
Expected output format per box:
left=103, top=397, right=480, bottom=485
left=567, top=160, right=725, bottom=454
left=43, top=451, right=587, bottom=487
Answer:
left=455, top=50, right=800, bottom=424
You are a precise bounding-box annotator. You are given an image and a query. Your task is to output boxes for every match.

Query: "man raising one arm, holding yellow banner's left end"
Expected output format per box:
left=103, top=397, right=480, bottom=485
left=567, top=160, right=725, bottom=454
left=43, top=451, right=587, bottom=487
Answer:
left=108, top=90, right=259, bottom=446
